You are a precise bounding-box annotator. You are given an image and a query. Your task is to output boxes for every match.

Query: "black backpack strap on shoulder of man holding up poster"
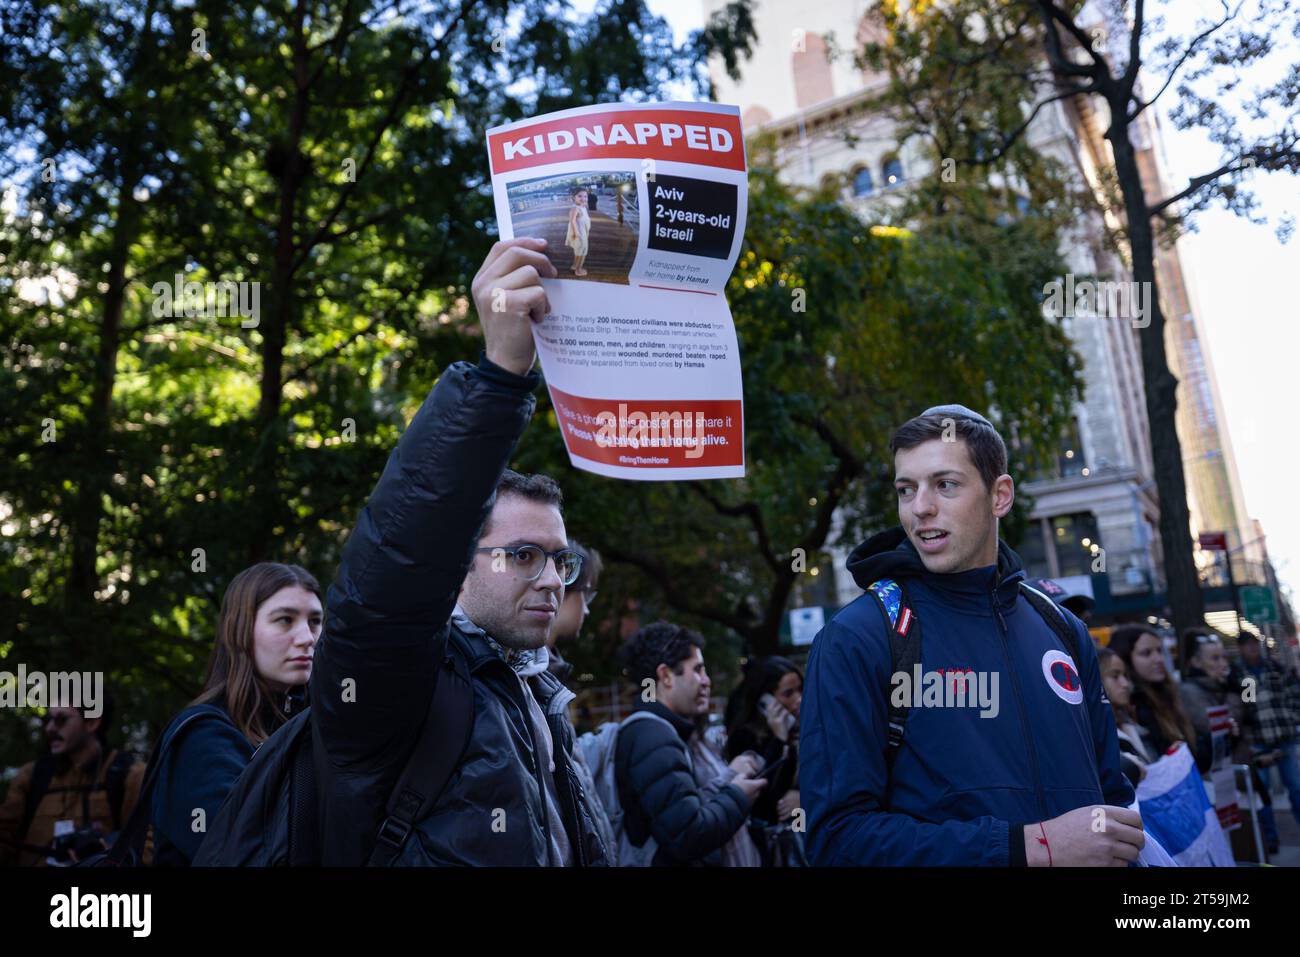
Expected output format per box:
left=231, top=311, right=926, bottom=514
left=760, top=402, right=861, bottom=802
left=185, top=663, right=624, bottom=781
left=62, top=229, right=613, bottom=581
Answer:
left=367, top=633, right=475, bottom=867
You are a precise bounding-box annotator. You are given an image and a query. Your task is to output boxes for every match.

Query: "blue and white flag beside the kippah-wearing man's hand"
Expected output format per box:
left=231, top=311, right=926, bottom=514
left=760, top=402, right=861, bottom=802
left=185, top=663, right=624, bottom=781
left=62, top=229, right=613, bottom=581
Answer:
left=1138, top=742, right=1236, bottom=867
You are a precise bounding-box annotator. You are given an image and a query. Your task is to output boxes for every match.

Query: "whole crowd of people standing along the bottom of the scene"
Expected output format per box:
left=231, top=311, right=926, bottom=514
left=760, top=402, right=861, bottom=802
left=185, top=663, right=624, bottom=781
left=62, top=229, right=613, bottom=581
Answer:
left=0, top=238, right=1300, bottom=867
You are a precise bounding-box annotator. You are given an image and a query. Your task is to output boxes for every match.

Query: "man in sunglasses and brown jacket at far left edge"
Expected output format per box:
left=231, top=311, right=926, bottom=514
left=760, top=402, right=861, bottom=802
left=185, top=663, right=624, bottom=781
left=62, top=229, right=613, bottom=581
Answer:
left=0, top=696, right=144, bottom=867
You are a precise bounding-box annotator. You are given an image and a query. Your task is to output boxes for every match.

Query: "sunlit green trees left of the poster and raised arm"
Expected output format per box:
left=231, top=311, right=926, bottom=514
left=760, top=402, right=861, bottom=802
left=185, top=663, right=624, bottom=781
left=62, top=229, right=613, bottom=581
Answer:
left=0, top=0, right=751, bottom=765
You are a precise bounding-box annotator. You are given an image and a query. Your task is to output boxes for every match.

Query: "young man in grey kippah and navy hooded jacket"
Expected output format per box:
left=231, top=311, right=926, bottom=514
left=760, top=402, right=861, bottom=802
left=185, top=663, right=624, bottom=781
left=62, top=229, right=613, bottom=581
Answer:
left=800, top=406, right=1144, bottom=867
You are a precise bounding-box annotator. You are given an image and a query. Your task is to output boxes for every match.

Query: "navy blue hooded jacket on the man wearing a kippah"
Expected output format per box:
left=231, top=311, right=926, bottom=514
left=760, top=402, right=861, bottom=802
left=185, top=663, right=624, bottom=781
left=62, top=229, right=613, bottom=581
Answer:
left=800, top=528, right=1134, bottom=866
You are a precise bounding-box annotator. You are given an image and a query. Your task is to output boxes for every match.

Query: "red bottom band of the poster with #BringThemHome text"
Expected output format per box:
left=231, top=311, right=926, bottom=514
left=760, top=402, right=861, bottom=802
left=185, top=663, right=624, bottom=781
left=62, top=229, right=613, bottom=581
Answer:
left=550, top=385, right=745, bottom=468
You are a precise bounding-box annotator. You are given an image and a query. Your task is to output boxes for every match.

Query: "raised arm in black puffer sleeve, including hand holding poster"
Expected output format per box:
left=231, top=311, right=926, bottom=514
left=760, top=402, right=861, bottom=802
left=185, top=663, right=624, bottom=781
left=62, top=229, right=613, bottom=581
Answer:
left=312, top=238, right=555, bottom=771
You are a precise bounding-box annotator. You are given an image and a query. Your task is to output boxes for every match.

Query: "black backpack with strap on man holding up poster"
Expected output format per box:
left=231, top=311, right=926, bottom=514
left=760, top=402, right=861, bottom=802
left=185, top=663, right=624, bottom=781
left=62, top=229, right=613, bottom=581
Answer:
left=192, top=638, right=475, bottom=867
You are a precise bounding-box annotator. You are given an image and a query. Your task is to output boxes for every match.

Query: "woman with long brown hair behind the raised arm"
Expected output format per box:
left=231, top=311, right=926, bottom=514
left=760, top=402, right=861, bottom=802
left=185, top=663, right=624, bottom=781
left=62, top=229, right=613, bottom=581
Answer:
left=151, top=562, right=324, bottom=866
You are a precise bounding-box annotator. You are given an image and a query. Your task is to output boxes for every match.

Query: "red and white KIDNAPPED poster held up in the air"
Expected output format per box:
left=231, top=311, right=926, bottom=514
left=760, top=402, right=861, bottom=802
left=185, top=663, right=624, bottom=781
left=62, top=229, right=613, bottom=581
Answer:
left=488, top=103, right=748, bottom=480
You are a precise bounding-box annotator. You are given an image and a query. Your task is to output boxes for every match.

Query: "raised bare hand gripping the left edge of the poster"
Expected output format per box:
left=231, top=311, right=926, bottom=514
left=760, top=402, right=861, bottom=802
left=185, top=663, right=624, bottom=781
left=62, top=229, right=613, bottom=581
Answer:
left=471, top=237, right=555, bottom=376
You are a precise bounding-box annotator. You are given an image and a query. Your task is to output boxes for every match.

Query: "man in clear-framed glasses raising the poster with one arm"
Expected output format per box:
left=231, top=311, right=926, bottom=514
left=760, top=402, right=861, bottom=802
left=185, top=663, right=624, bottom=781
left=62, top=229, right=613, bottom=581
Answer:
left=312, top=238, right=606, bottom=866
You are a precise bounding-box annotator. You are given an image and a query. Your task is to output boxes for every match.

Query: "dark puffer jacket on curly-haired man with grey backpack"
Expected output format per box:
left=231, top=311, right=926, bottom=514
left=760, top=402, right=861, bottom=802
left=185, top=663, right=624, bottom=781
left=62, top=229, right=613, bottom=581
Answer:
left=614, top=701, right=749, bottom=867
